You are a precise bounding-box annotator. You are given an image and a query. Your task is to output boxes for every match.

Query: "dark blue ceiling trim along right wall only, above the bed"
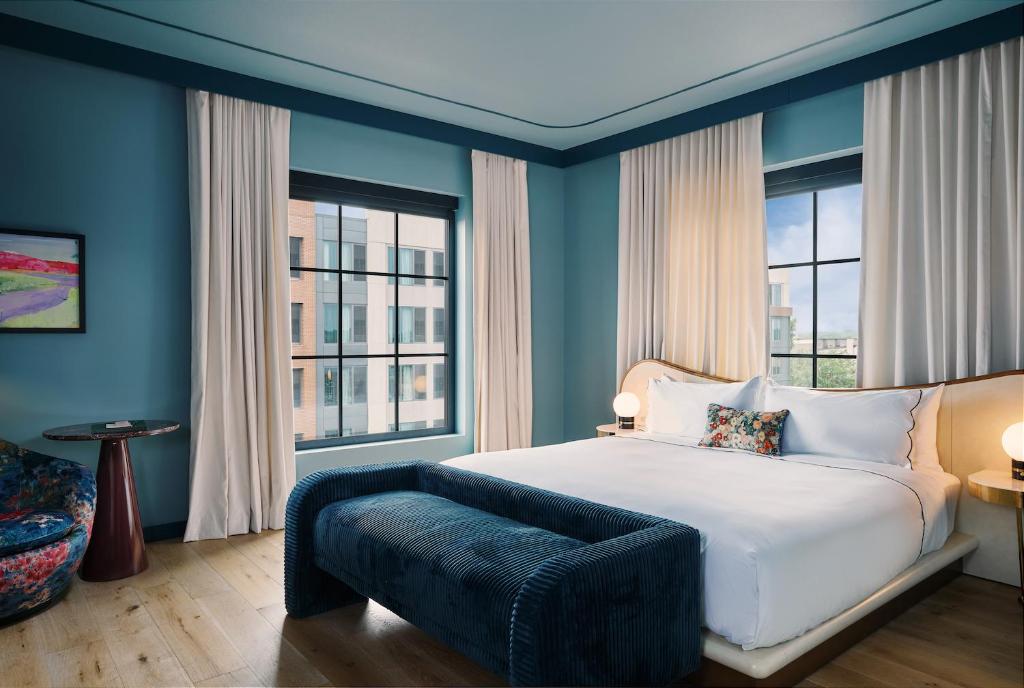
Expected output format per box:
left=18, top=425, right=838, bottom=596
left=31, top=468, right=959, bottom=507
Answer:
left=562, top=4, right=1024, bottom=167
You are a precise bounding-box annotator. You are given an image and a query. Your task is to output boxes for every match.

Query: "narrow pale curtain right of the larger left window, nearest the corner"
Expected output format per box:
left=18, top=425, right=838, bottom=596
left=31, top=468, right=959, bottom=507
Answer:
left=473, top=151, right=534, bottom=452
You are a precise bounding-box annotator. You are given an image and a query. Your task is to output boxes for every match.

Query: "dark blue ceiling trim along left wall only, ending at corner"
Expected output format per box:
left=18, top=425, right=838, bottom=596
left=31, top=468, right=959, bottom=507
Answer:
left=0, top=13, right=562, bottom=167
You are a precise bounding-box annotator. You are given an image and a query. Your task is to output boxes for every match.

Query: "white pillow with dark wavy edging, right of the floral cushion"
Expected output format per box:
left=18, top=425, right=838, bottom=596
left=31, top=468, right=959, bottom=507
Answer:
left=765, top=384, right=924, bottom=468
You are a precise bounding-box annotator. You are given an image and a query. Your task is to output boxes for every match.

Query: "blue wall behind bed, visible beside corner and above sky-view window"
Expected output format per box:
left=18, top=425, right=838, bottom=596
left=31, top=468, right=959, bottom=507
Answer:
left=564, top=86, right=863, bottom=440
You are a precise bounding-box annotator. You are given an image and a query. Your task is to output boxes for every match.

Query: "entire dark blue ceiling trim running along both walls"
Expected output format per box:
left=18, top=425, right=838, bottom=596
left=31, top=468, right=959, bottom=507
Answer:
left=0, top=4, right=1024, bottom=167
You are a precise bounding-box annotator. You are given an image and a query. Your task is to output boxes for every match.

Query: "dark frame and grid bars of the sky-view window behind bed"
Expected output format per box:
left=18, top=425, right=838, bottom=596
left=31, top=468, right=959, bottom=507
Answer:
left=764, top=153, right=863, bottom=389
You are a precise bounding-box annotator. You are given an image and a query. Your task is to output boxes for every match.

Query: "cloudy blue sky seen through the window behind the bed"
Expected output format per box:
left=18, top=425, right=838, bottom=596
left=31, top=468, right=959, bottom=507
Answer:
left=766, top=184, right=860, bottom=337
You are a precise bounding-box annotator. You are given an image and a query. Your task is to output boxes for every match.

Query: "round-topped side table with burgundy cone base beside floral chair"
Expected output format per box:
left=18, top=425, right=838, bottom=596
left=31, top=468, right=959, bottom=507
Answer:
left=43, top=421, right=180, bottom=581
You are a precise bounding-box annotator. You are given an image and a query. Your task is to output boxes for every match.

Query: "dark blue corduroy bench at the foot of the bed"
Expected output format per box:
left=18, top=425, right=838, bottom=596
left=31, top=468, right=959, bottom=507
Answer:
left=285, top=462, right=700, bottom=686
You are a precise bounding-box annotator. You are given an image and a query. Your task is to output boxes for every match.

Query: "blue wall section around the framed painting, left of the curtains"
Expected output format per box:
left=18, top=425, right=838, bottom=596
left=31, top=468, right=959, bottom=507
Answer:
left=0, top=48, right=191, bottom=524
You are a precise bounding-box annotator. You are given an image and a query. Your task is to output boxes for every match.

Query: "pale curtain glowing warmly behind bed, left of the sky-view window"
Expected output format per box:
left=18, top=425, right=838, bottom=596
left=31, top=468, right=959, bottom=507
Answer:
left=617, top=115, right=768, bottom=379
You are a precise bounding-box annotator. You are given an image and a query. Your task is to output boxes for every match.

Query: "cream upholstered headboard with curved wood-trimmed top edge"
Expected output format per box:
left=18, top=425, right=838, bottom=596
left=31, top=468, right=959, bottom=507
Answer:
left=620, top=359, right=1024, bottom=585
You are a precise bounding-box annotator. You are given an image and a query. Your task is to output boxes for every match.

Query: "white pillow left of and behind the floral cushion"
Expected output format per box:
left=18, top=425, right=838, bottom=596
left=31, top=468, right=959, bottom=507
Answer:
left=647, top=377, right=761, bottom=438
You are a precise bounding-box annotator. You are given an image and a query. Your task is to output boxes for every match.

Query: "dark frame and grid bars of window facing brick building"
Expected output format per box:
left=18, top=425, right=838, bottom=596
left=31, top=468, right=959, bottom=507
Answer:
left=289, top=170, right=459, bottom=450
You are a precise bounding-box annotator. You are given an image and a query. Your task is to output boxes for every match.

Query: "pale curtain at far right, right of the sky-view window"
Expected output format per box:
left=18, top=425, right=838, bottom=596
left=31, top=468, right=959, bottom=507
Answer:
left=857, top=38, right=1024, bottom=386
